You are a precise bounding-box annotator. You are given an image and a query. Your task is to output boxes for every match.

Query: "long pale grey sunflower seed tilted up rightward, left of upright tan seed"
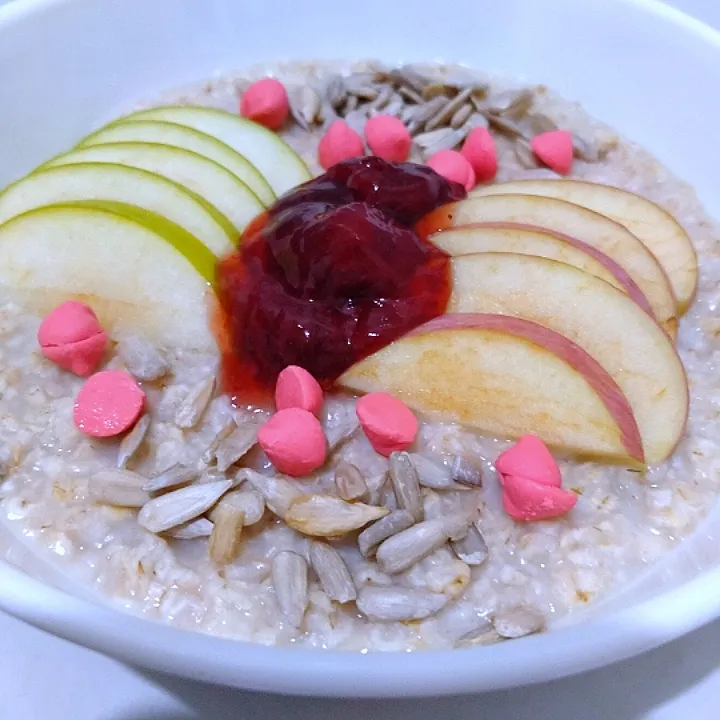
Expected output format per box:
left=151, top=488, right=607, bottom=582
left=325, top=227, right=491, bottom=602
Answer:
left=138, top=480, right=233, bottom=533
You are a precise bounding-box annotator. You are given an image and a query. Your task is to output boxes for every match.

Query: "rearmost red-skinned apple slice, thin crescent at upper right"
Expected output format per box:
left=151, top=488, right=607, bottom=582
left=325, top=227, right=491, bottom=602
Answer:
left=472, top=180, right=698, bottom=313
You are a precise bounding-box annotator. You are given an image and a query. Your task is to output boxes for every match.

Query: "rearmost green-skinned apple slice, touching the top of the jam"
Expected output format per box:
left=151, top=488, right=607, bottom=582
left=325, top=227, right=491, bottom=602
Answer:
left=116, top=105, right=312, bottom=196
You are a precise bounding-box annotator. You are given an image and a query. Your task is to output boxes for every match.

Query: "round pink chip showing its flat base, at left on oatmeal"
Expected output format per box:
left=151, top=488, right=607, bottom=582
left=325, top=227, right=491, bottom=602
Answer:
left=73, top=370, right=145, bottom=438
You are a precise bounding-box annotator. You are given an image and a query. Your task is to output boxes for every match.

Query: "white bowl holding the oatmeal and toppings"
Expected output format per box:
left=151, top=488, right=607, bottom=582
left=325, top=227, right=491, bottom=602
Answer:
left=0, top=0, right=720, bottom=697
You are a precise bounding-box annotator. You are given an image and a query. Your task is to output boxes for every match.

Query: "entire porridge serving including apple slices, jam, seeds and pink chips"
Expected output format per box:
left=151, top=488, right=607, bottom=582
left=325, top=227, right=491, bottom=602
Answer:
left=0, top=59, right=718, bottom=650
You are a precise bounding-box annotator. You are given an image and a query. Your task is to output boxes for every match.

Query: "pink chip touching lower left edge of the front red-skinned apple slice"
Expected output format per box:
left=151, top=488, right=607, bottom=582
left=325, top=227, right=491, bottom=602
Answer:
left=355, top=393, right=418, bottom=457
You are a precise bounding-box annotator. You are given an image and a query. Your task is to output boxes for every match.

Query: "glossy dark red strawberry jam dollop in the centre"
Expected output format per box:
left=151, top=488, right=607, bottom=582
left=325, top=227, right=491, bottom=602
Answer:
left=216, top=157, right=465, bottom=404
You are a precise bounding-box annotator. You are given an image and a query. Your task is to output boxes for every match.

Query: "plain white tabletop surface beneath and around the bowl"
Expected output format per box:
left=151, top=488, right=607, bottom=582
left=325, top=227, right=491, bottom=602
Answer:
left=0, top=0, right=720, bottom=720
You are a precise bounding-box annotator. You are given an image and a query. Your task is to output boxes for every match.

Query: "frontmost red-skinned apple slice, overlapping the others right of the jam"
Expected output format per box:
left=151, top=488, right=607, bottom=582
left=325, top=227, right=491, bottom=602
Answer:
left=340, top=313, right=644, bottom=465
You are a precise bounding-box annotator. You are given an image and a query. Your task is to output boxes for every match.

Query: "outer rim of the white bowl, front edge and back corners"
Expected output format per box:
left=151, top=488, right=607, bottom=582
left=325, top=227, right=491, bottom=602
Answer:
left=0, top=0, right=720, bottom=697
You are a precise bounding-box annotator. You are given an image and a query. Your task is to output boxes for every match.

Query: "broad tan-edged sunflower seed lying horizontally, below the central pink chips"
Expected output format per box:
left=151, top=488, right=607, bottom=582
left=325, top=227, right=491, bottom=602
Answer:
left=284, top=495, right=390, bottom=537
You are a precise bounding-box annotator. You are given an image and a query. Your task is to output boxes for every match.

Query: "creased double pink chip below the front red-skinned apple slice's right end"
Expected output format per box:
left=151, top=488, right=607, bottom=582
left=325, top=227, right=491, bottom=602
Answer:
left=495, top=435, right=577, bottom=522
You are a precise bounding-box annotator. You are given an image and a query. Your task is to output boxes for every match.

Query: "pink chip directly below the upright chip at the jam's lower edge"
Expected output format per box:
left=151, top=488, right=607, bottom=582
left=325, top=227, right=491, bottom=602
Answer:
left=258, top=408, right=327, bottom=477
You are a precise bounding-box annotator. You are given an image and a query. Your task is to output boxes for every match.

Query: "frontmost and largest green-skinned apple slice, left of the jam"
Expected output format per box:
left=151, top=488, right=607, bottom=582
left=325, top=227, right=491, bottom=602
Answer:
left=0, top=205, right=215, bottom=351
